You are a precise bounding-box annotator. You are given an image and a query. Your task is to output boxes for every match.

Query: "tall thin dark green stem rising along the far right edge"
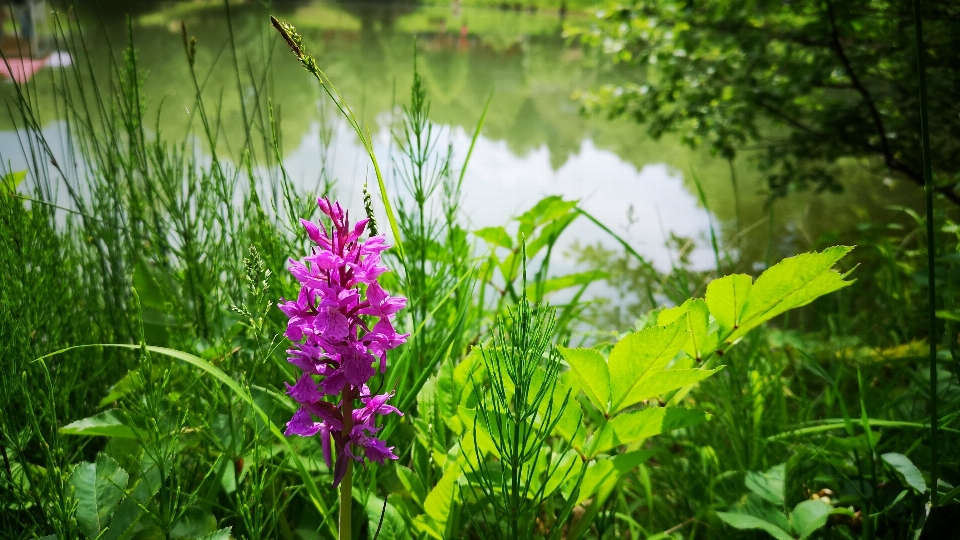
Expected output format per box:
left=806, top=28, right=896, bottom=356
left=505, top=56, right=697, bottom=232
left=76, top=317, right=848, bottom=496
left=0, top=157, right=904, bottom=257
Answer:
left=913, top=0, right=939, bottom=506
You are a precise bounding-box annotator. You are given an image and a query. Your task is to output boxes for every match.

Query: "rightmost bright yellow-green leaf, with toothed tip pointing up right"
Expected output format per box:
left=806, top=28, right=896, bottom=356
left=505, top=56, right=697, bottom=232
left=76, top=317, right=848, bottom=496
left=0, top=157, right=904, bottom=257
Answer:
left=732, top=246, right=853, bottom=342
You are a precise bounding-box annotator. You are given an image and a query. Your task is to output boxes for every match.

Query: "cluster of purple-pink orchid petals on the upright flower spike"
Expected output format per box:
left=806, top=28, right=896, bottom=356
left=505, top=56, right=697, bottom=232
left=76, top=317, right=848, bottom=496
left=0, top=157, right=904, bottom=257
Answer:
left=278, top=198, right=409, bottom=486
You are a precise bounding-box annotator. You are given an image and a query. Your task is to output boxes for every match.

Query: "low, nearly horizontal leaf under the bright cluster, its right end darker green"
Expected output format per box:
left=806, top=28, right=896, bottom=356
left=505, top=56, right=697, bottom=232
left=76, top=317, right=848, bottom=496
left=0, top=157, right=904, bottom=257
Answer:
left=589, top=407, right=710, bottom=456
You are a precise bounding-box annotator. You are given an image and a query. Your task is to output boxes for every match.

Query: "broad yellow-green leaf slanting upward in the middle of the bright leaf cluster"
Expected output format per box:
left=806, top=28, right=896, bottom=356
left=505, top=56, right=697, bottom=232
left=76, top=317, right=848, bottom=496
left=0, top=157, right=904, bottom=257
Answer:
left=608, top=315, right=689, bottom=414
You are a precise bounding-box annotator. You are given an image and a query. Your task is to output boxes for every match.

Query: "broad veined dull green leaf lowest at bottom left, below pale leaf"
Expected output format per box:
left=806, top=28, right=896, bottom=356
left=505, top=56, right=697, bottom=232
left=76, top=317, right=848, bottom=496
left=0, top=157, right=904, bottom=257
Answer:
left=68, top=453, right=130, bottom=538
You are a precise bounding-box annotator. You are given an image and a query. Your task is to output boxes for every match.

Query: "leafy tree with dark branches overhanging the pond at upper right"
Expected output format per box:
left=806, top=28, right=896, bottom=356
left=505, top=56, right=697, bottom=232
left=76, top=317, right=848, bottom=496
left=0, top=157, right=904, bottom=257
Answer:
left=570, top=0, right=960, bottom=200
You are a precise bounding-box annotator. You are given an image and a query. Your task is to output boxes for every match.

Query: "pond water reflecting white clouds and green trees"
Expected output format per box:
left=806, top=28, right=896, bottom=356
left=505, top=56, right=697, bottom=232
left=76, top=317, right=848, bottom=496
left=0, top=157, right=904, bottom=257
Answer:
left=0, top=1, right=919, bottom=276
